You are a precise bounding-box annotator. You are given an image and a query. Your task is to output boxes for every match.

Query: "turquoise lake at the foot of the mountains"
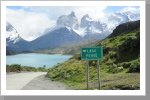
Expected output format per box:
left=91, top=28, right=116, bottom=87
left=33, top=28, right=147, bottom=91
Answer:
left=6, top=53, right=72, bottom=68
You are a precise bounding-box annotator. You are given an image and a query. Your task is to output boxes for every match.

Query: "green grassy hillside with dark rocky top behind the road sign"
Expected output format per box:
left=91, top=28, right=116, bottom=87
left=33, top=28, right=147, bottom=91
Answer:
left=47, top=21, right=140, bottom=90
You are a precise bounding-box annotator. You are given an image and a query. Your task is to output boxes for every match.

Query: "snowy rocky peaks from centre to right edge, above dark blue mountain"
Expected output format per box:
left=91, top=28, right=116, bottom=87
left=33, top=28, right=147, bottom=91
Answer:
left=47, top=11, right=140, bottom=38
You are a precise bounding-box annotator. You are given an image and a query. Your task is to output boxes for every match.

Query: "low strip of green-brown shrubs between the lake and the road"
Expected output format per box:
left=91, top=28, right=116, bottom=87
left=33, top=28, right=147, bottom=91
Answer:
left=6, top=64, right=47, bottom=73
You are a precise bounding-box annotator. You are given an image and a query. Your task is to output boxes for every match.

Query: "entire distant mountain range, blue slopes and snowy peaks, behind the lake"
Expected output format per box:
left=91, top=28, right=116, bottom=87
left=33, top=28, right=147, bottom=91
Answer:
left=6, top=11, right=140, bottom=51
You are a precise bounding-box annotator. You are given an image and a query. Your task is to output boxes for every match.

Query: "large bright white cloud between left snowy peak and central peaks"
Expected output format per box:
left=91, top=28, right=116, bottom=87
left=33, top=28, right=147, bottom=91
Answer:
left=6, top=9, right=53, bottom=40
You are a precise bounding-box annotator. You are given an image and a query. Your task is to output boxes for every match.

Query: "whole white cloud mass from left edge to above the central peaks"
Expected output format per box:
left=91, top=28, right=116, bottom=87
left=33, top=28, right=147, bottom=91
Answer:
left=6, top=6, right=106, bottom=40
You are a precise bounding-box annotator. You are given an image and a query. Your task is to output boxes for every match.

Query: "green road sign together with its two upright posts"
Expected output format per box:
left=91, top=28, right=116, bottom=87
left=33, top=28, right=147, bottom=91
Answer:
left=81, top=47, right=103, bottom=90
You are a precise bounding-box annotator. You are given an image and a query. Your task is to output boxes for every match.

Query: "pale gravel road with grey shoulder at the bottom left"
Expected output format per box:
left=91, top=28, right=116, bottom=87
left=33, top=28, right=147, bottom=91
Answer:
left=6, top=72, right=71, bottom=90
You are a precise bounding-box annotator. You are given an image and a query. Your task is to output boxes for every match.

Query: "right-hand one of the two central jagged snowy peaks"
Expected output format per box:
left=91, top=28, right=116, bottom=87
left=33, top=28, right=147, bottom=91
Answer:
left=78, top=14, right=110, bottom=38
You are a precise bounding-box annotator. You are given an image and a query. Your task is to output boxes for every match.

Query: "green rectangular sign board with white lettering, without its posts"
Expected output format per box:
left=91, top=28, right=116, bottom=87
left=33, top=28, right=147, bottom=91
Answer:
left=81, top=47, right=103, bottom=60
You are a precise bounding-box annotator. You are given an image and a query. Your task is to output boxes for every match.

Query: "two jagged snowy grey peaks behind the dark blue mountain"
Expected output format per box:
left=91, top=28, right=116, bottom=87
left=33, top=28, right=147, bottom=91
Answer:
left=53, top=11, right=110, bottom=39
